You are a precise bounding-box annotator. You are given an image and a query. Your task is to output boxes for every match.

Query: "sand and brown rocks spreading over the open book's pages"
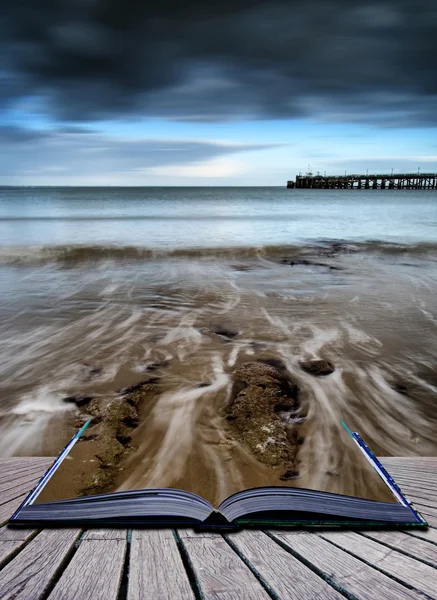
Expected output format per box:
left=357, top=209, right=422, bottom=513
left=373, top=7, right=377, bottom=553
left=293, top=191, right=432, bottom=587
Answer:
left=35, top=361, right=396, bottom=506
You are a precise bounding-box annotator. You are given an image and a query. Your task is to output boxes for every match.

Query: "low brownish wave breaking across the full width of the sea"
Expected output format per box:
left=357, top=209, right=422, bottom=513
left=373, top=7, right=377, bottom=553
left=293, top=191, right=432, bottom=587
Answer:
left=0, top=240, right=437, bottom=265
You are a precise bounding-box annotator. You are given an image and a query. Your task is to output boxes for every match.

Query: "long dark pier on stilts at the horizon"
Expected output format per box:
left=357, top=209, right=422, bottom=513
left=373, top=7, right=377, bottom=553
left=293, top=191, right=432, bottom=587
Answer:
left=287, top=173, right=437, bottom=190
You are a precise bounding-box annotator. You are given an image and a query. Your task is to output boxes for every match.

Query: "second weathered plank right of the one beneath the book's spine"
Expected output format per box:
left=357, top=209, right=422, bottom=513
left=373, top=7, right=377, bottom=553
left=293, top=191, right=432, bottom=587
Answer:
left=270, top=531, right=422, bottom=600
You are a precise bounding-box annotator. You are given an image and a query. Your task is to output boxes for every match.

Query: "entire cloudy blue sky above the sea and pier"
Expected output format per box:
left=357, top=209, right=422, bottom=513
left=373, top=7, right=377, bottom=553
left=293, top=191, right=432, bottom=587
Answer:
left=0, top=0, right=437, bottom=186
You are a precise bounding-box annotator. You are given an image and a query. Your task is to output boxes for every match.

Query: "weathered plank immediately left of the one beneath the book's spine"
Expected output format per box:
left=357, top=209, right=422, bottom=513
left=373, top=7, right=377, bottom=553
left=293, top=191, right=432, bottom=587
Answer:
left=126, top=529, right=194, bottom=600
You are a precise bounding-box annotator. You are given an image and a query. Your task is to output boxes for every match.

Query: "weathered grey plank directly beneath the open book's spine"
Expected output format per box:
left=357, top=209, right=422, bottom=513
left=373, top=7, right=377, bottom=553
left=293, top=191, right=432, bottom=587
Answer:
left=182, top=536, right=269, bottom=600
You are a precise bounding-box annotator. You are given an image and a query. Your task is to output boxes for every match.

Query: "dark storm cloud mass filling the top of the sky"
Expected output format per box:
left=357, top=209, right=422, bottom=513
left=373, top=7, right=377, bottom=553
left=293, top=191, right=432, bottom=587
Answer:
left=0, top=0, right=437, bottom=125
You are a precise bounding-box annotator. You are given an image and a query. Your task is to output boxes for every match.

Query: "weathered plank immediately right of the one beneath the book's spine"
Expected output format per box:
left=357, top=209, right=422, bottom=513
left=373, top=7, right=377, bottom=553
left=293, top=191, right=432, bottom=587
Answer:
left=226, top=530, right=343, bottom=600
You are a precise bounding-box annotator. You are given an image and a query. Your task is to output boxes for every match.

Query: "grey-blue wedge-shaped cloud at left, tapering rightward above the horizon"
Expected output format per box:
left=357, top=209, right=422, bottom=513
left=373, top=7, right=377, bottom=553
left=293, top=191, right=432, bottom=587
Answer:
left=0, top=126, right=278, bottom=183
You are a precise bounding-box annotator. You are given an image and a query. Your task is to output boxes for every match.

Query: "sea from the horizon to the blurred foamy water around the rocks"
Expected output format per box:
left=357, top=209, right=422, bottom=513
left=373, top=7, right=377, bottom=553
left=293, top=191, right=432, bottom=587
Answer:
left=0, top=187, right=437, bottom=496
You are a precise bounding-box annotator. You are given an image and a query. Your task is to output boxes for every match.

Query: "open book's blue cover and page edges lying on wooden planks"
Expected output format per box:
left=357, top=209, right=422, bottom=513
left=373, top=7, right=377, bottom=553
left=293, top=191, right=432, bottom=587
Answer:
left=10, top=422, right=427, bottom=529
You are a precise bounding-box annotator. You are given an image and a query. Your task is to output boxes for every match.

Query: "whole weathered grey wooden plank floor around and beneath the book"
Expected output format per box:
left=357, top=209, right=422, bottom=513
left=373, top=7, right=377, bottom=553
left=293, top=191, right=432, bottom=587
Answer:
left=0, top=457, right=437, bottom=600
